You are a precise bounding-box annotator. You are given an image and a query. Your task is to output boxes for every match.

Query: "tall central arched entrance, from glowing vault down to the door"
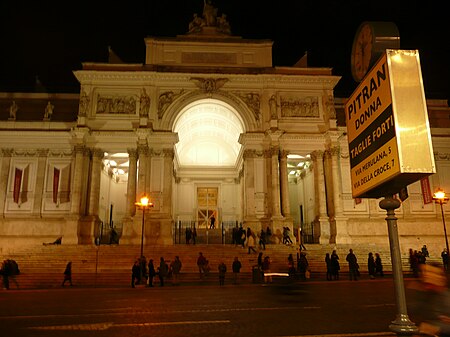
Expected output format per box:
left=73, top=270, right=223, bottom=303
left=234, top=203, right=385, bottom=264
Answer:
left=173, top=98, right=245, bottom=242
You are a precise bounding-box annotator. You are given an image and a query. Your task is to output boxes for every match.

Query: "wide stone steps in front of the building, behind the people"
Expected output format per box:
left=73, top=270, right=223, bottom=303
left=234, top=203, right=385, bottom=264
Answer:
left=0, top=244, right=442, bottom=289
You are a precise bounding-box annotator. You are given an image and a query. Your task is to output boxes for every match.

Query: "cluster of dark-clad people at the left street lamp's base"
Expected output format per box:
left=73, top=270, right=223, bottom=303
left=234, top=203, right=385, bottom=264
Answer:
left=131, top=256, right=182, bottom=288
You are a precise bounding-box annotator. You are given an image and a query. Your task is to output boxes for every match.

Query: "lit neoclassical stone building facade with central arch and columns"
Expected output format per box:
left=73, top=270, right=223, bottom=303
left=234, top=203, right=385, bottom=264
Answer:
left=0, top=7, right=450, bottom=255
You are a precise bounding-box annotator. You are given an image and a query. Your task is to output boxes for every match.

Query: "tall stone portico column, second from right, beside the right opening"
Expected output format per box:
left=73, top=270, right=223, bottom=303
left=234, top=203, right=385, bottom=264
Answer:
left=311, top=151, right=330, bottom=244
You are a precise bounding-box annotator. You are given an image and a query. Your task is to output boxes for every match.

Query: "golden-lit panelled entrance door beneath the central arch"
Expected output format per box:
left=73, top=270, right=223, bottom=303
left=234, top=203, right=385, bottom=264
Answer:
left=197, top=187, right=218, bottom=228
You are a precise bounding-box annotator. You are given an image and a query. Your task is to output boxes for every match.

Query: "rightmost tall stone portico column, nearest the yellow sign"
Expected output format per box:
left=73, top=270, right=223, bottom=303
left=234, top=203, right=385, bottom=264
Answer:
left=330, top=147, right=351, bottom=243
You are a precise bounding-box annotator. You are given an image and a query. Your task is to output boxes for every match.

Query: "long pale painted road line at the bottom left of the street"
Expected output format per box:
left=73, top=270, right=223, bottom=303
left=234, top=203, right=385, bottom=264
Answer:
left=27, top=320, right=231, bottom=331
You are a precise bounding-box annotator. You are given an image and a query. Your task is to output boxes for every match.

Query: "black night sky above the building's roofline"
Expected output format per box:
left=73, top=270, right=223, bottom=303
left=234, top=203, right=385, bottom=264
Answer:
left=0, top=0, right=450, bottom=99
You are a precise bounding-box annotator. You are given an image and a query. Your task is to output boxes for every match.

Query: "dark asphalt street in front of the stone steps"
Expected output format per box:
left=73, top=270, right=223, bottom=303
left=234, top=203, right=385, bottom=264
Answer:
left=0, top=279, right=428, bottom=337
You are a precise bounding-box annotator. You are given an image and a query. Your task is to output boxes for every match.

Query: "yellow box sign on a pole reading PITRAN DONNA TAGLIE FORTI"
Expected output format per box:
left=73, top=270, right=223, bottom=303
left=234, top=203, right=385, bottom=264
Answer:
left=345, top=49, right=435, bottom=198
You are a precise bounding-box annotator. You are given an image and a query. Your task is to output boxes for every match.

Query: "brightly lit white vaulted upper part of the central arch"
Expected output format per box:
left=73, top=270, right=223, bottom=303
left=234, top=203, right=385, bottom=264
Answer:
left=174, top=99, right=244, bottom=167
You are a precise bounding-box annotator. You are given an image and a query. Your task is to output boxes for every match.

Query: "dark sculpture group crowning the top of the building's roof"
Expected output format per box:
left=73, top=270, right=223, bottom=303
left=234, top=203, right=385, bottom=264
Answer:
left=188, top=0, right=231, bottom=35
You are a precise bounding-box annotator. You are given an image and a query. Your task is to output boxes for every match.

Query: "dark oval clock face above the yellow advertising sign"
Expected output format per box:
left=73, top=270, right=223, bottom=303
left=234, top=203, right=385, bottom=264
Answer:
left=351, top=23, right=374, bottom=82
